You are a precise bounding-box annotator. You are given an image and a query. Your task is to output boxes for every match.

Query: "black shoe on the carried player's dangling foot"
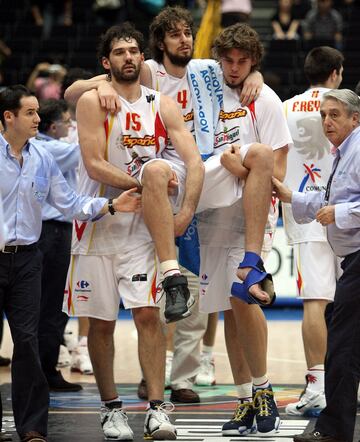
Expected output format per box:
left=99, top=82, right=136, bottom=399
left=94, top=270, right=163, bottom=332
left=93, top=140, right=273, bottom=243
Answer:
left=162, top=275, right=194, bottom=323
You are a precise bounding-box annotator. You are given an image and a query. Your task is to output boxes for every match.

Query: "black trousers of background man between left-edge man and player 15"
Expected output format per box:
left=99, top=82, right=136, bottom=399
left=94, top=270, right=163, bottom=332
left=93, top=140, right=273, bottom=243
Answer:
left=39, top=221, right=72, bottom=383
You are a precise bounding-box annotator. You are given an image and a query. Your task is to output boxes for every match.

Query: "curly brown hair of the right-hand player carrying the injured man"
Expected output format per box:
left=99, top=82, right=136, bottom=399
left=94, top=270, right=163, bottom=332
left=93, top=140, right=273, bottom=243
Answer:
left=213, top=23, right=264, bottom=71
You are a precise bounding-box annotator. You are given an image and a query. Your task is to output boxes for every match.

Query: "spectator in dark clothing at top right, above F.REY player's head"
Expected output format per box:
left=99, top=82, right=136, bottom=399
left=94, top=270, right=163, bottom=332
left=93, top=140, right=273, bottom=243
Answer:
left=303, top=0, right=343, bottom=50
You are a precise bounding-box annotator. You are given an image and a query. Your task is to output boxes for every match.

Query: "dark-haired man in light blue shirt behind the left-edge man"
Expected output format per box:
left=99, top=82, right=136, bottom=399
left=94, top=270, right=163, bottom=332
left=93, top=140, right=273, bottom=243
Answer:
left=31, top=99, right=82, bottom=392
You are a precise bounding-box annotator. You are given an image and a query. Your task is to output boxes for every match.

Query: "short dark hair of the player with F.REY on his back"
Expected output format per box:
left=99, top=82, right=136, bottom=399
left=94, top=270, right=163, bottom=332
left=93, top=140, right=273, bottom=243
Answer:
left=304, top=46, right=344, bottom=85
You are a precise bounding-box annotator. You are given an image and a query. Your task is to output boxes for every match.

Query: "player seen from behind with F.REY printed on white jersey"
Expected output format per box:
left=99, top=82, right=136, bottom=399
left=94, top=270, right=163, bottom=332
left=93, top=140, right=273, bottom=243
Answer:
left=283, top=46, right=344, bottom=416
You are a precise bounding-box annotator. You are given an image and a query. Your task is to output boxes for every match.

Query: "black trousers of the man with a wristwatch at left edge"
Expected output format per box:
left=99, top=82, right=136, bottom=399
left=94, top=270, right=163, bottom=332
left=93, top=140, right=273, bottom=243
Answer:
left=0, top=248, right=49, bottom=437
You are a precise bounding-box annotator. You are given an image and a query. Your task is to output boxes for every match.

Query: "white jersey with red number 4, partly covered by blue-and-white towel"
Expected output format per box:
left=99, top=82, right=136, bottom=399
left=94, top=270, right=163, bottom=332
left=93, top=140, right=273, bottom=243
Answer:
left=145, top=60, right=195, bottom=162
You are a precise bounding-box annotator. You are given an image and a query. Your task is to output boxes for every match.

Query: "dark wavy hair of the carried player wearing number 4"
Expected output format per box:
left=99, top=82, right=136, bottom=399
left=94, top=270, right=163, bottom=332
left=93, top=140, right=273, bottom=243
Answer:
left=149, top=6, right=194, bottom=63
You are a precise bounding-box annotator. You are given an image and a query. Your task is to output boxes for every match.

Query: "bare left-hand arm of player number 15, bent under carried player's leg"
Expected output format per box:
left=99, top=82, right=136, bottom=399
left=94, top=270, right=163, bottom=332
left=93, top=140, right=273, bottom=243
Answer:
left=76, top=90, right=141, bottom=190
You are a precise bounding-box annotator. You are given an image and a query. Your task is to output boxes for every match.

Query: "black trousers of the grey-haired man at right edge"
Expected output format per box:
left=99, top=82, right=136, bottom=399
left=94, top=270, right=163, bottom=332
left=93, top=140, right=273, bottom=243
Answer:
left=315, top=251, right=360, bottom=442
